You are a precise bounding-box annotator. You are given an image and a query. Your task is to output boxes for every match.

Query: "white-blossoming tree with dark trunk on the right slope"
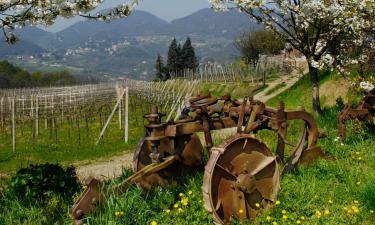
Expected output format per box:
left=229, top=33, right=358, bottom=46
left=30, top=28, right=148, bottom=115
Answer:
left=209, top=0, right=375, bottom=113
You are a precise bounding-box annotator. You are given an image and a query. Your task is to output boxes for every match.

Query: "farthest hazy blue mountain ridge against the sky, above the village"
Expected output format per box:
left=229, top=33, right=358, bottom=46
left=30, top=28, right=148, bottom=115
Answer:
left=29, top=9, right=261, bottom=49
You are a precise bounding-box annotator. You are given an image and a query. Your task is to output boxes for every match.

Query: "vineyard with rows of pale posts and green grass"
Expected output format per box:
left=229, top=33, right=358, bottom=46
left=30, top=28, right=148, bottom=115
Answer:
left=0, top=79, right=266, bottom=172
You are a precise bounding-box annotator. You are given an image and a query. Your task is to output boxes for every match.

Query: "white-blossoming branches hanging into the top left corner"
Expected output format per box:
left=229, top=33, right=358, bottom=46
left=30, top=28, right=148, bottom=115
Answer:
left=0, top=0, right=138, bottom=43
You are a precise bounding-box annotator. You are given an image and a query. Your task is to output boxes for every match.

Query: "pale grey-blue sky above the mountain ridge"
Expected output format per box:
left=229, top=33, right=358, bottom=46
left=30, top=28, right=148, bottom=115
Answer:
left=42, top=0, right=210, bottom=32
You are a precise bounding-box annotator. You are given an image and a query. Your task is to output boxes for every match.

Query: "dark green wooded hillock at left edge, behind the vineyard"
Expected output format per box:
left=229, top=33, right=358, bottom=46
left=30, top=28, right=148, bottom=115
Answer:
left=0, top=61, right=77, bottom=88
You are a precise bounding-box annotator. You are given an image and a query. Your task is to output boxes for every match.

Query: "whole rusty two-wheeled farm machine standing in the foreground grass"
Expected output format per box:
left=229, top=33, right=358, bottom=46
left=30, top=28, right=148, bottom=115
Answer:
left=72, top=96, right=323, bottom=225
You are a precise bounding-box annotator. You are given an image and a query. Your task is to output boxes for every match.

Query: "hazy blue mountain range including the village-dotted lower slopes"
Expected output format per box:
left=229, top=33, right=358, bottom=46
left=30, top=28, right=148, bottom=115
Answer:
left=0, top=9, right=262, bottom=79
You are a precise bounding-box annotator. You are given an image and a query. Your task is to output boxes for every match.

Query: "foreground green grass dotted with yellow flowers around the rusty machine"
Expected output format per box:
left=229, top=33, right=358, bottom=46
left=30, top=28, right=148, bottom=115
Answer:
left=0, top=74, right=375, bottom=225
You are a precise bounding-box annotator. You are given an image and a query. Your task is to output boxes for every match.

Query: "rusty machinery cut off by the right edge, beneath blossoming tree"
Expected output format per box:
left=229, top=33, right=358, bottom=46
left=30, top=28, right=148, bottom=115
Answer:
left=338, top=89, right=375, bottom=138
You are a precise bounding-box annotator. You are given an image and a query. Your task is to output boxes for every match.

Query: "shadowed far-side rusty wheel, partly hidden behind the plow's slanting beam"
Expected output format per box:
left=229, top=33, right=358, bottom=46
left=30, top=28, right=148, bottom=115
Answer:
left=133, top=135, right=203, bottom=191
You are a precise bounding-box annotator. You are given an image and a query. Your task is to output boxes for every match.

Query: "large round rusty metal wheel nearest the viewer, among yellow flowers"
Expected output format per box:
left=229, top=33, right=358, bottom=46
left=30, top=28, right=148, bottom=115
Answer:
left=202, top=135, right=280, bottom=224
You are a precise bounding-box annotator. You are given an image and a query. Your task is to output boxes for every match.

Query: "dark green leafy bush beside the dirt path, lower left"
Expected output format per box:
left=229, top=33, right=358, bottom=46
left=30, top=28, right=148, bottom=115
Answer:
left=9, top=163, right=80, bottom=205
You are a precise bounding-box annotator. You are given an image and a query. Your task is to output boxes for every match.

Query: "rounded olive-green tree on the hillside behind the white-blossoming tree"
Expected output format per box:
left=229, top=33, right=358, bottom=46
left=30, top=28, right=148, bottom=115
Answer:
left=234, top=30, right=285, bottom=67
